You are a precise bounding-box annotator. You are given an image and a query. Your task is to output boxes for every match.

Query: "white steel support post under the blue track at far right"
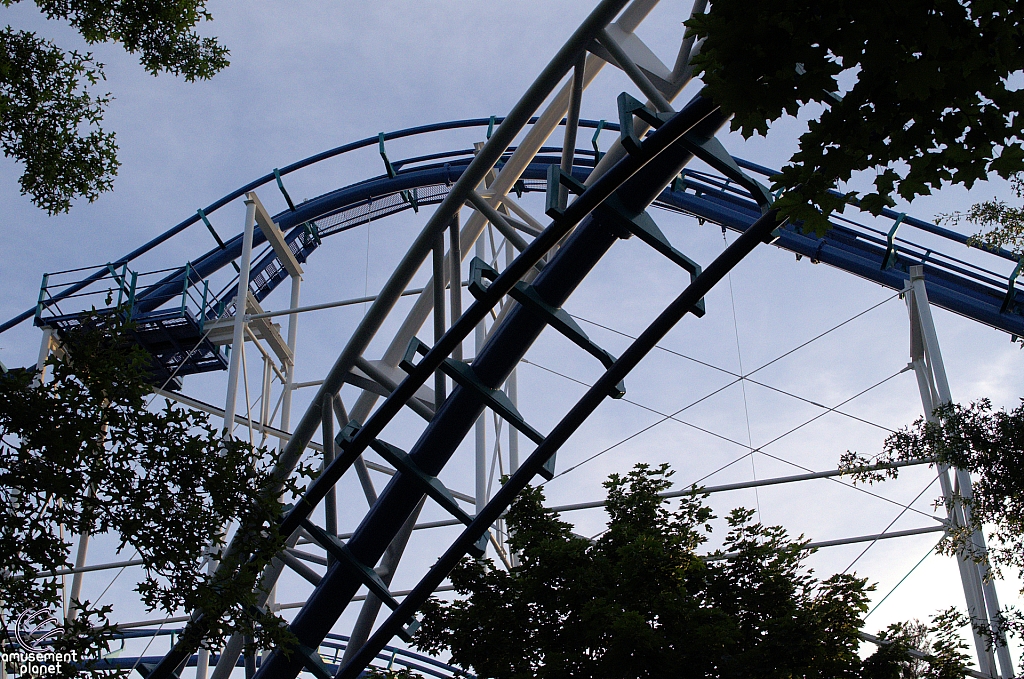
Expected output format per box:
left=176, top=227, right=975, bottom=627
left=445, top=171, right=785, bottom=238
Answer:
left=904, top=266, right=1014, bottom=679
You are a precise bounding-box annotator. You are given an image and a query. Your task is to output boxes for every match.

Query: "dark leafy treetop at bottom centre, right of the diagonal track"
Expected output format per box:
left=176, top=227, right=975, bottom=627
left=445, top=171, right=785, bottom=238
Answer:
left=416, top=465, right=966, bottom=679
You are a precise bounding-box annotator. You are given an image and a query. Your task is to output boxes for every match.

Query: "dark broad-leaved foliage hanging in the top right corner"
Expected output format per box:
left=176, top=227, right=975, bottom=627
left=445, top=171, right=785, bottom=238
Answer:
left=687, top=0, right=1024, bottom=232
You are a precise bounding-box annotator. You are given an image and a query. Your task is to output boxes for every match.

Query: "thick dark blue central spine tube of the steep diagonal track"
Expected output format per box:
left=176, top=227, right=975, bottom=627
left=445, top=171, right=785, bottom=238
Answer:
left=251, top=98, right=724, bottom=679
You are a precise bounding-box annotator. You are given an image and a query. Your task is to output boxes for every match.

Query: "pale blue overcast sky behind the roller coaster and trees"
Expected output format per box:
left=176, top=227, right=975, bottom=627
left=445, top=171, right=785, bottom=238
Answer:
left=0, top=0, right=1024, bottom=675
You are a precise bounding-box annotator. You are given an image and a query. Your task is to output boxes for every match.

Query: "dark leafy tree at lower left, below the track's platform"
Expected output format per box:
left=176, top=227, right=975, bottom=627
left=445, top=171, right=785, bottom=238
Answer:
left=0, top=315, right=292, bottom=676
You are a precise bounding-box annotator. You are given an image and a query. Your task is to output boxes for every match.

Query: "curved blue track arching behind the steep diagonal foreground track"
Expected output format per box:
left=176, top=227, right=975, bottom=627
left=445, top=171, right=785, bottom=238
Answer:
left=8, top=118, right=1024, bottom=348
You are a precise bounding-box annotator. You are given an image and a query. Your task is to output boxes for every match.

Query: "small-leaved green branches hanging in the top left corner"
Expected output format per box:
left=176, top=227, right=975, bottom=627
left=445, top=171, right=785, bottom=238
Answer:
left=0, top=0, right=228, bottom=214
